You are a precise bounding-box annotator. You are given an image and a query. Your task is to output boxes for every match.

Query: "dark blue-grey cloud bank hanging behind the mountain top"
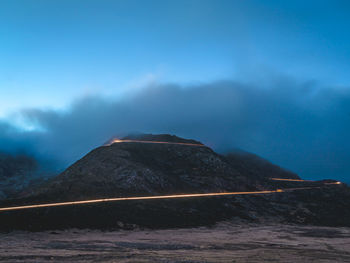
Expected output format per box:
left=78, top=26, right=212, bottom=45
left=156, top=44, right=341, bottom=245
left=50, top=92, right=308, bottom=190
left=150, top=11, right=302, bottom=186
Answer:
left=0, top=79, right=350, bottom=182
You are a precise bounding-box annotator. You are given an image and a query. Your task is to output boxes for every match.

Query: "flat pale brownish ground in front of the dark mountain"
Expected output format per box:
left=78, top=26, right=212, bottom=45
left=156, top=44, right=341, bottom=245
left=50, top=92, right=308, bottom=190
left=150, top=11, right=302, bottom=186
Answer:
left=0, top=223, right=350, bottom=263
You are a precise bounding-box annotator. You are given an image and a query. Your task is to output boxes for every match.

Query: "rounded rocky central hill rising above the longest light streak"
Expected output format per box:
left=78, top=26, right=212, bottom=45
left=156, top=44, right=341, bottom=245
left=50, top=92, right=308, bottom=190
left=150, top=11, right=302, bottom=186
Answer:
left=35, top=135, right=256, bottom=200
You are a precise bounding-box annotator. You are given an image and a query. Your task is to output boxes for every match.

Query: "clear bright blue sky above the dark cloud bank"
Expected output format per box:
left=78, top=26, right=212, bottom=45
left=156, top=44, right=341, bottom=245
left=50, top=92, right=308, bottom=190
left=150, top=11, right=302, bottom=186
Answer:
left=0, top=0, right=350, bottom=115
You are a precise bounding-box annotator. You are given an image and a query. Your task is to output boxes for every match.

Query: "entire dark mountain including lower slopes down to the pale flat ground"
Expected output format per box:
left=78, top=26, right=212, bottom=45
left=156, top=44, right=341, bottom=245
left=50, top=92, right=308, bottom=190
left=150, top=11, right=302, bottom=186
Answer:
left=0, top=134, right=350, bottom=230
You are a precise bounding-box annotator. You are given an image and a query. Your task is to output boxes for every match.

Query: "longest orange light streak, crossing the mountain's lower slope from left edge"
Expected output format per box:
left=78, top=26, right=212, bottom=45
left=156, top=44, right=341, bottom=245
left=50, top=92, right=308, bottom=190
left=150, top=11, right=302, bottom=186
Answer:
left=0, top=187, right=300, bottom=211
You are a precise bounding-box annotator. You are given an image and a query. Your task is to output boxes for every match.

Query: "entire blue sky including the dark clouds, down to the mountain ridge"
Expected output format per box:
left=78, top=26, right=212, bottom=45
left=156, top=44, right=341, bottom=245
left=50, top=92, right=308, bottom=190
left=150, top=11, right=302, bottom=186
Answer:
left=0, top=0, right=350, bottom=182
